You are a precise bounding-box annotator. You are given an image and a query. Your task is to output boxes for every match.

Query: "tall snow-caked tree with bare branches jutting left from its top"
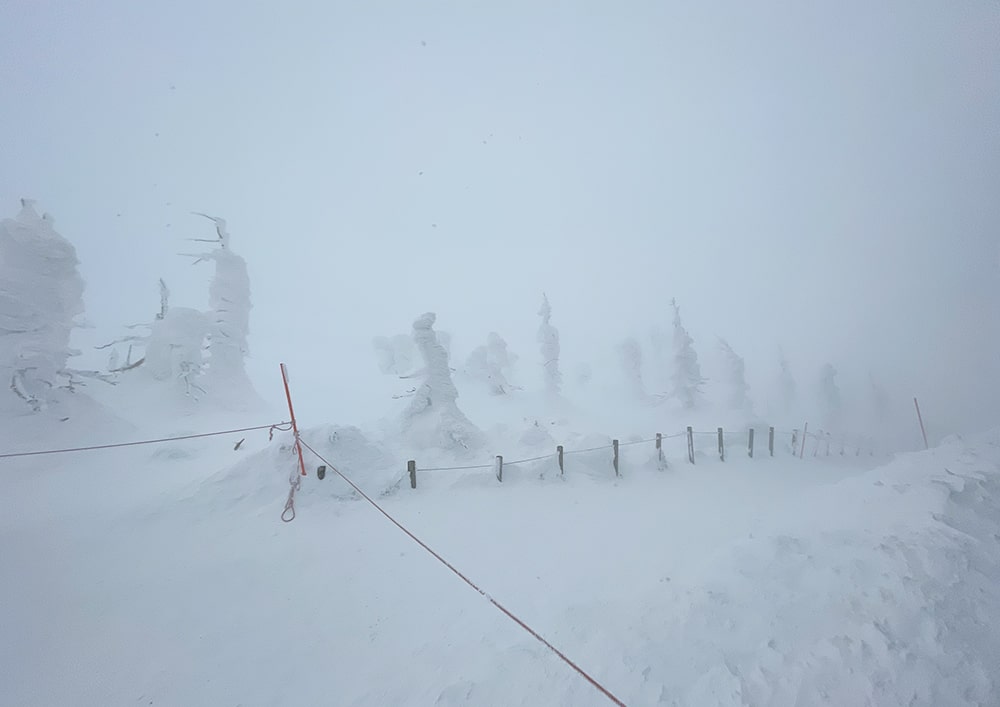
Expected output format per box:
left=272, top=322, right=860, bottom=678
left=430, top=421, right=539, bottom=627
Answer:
left=186, top=213, right=252, bottom=393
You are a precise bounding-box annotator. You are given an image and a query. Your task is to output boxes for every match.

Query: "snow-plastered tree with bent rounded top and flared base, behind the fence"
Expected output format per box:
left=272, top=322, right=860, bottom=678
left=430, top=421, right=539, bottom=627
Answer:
left=402, top=312, right=482, bottom=451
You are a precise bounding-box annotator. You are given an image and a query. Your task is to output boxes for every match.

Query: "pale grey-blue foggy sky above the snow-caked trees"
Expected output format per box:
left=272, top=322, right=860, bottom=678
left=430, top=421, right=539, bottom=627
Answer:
left=0, top=0, right=1000, bottom=436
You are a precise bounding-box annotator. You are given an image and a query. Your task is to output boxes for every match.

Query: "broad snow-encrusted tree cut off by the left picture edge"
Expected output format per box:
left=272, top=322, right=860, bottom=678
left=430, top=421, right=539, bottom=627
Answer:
left=0, top=199, right=84, bottom=411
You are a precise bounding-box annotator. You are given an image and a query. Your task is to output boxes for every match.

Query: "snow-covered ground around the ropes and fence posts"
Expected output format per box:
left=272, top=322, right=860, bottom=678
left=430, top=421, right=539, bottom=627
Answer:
left=0, top=396, right=1000, bottom=707
